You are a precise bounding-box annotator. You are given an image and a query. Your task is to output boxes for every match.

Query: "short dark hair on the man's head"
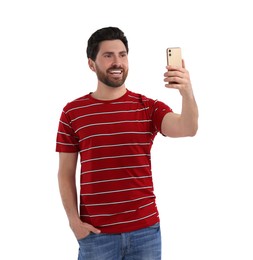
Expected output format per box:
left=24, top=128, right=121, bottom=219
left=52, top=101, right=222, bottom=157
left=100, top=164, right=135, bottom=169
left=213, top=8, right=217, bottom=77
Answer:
left=86, top=27, right=128, bottom=61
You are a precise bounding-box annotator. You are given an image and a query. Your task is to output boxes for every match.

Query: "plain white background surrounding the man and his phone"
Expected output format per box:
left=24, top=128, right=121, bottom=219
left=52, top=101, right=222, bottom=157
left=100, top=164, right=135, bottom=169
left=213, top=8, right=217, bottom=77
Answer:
left=0, top=0, right=253, bottom=260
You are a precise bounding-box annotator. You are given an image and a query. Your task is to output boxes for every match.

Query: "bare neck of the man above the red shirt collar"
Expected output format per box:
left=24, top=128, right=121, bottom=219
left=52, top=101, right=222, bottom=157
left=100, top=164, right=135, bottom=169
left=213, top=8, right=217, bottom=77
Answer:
left=91, top=85, right=127, bottom=100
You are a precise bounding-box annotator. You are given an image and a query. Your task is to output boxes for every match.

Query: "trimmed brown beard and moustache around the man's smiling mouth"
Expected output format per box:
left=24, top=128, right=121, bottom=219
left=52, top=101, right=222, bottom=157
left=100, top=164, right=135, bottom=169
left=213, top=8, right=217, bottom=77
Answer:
left=95, top=65, right=128, bottom=88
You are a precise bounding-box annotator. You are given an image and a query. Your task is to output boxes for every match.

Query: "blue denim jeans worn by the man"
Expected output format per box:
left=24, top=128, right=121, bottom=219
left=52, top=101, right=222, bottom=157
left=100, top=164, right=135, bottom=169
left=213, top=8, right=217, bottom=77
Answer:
left=78, top=223, right=161, bottom=260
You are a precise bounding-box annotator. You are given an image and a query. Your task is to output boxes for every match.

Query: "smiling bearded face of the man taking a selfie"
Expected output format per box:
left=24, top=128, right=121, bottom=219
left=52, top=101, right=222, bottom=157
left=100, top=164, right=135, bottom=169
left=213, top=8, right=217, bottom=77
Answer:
left=91, top=40, right=128, bottom=88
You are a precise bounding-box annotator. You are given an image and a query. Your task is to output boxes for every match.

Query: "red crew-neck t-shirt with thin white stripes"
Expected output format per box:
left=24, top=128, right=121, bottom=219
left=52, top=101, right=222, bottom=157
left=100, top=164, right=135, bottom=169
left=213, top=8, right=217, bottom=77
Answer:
left=56, top=90, right=172, bottom=233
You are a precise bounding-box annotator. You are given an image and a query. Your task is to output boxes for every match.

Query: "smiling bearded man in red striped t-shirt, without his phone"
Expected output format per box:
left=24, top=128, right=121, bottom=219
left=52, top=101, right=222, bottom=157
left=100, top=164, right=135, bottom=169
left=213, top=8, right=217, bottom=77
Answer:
left=56, top=27, right=198, bottom=260
